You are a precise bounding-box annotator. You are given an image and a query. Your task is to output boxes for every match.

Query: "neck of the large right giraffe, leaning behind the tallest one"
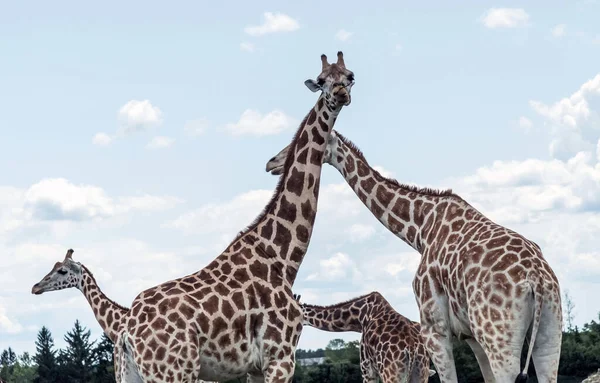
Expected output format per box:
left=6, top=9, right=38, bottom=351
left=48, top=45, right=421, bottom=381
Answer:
left=324, top=131, right=456, bottom=253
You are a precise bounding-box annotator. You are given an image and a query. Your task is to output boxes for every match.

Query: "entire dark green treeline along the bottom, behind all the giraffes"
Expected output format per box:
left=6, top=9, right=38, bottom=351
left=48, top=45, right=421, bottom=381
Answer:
left=0, top=312, right=600, bottom=383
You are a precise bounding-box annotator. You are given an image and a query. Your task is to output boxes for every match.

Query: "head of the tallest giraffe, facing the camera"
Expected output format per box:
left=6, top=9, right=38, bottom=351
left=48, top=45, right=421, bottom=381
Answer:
left=304, top=51, right=354, bottom=110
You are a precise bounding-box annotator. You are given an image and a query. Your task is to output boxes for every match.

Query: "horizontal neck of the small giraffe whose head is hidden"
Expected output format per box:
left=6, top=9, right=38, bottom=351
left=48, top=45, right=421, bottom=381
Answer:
left=301, top=292, right=391, bottom=332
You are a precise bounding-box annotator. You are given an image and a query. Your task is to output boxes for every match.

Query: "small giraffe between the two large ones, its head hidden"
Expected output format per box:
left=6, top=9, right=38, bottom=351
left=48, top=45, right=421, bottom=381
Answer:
left=294, top=291, right=435, bottom=383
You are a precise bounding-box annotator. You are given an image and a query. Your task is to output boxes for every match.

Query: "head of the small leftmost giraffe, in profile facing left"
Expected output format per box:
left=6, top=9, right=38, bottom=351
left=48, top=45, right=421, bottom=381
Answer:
left=31, top=249, right=83, bottom=295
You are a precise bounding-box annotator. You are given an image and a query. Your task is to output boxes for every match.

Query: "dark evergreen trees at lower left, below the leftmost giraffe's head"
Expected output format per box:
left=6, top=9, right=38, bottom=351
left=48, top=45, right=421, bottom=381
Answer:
left=0, top=321, right=115, bottom=383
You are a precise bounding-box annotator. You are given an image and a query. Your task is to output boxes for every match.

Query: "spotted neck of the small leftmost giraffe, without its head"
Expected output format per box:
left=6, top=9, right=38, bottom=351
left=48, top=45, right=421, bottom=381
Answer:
left=77, top=265, right=129, bottom=342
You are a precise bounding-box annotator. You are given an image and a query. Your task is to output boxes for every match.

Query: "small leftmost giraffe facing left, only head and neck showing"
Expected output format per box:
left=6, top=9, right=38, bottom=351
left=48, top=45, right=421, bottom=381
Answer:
left=31, top=249, right=129, bottom=343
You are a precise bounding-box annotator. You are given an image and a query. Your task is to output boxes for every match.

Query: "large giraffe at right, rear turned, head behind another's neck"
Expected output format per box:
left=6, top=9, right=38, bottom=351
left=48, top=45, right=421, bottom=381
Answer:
left=266, top=131, right=562, bottom=382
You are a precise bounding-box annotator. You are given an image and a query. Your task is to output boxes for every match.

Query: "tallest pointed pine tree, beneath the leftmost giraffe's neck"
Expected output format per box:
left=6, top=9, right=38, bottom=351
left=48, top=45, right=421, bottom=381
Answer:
left=59, top=320, right=95, bottom=383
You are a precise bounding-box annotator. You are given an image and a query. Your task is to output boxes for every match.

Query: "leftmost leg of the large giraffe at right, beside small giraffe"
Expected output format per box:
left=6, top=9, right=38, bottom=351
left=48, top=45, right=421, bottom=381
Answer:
left=417, top=292, right=458, bottom=383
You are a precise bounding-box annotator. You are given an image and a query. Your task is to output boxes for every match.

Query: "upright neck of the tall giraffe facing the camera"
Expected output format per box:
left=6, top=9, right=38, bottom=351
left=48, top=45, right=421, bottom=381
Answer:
left=230, top=94, right=341, bottom=287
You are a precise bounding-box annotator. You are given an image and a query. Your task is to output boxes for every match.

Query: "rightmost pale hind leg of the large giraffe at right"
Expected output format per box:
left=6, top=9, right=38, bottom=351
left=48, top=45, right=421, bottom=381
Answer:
left=530, top=299, right=562, bottom=383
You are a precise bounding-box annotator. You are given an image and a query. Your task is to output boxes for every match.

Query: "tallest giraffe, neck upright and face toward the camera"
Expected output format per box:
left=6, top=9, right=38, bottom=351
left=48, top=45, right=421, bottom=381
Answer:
left=108, top=52, right=354, bottom=383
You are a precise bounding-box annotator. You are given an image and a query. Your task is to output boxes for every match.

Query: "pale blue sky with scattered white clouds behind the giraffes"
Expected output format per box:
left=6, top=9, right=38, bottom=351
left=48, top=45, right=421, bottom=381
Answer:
left=0, top=0, right=600, bottom=352
